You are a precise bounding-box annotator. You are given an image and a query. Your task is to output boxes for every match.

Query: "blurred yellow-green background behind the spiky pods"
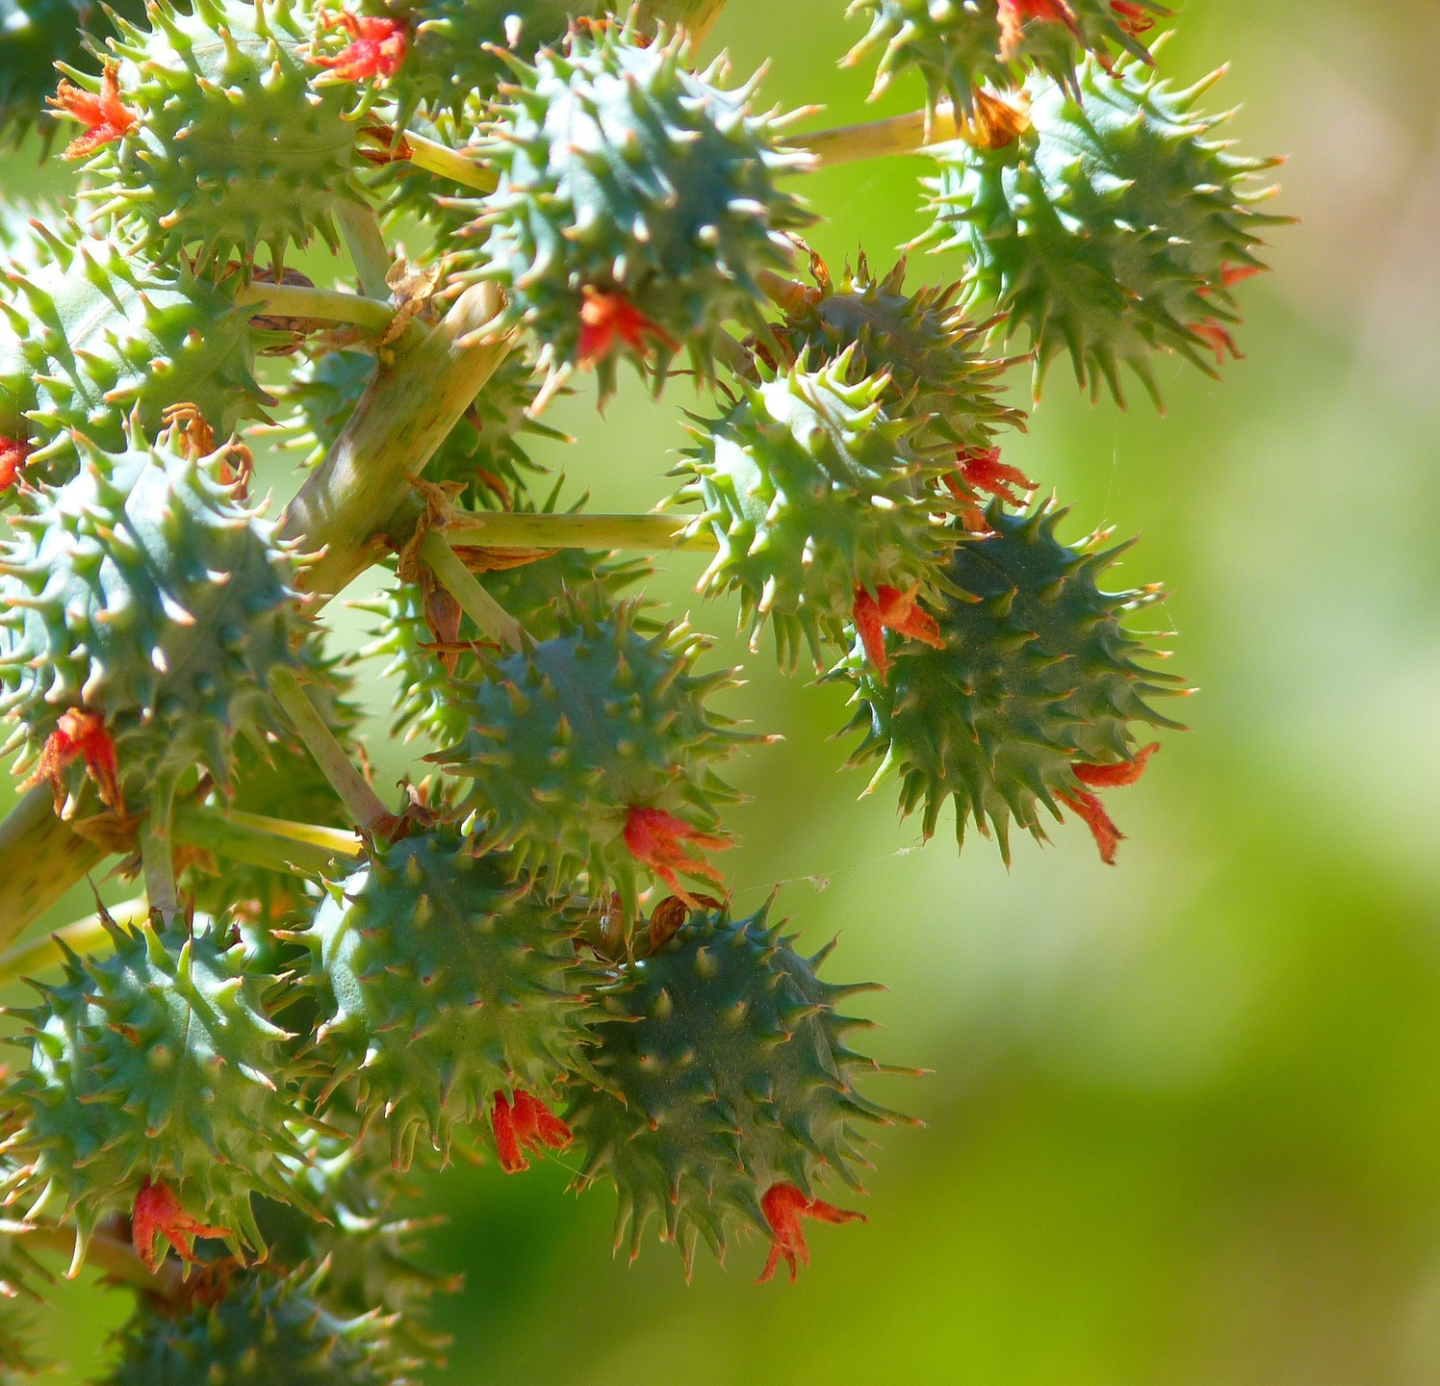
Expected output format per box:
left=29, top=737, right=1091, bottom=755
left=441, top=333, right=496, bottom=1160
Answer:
left=0, top=0, right=1440, bottom=1386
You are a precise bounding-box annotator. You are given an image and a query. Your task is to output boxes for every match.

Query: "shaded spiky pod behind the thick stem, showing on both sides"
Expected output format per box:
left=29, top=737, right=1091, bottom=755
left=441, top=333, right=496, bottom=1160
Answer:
left=284, top=352, right=558, bottom=507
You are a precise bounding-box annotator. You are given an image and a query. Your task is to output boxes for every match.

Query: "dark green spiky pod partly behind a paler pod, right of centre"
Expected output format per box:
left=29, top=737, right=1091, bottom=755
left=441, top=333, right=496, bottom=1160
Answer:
left=837, top=501, right=1181, bottom=860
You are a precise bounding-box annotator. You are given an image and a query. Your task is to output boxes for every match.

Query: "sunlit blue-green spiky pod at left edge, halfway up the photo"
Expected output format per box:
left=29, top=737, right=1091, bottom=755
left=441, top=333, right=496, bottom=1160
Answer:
left=0, top=421, right=318, bottom=817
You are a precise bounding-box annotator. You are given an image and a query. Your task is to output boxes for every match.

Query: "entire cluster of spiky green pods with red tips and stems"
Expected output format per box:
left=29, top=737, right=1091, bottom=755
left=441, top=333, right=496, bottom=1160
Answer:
left=0, top=0, right=1277, bottom=1365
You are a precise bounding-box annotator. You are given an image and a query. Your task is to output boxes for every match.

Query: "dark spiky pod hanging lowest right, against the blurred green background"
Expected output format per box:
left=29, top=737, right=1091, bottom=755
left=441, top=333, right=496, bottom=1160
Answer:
left=566, top=906, right=897, bottom=1268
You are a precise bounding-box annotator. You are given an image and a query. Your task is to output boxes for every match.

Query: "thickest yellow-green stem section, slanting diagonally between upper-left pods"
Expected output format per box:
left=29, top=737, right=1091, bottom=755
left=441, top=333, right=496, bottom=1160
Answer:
left=281, top=284, right=511, bottom=599
